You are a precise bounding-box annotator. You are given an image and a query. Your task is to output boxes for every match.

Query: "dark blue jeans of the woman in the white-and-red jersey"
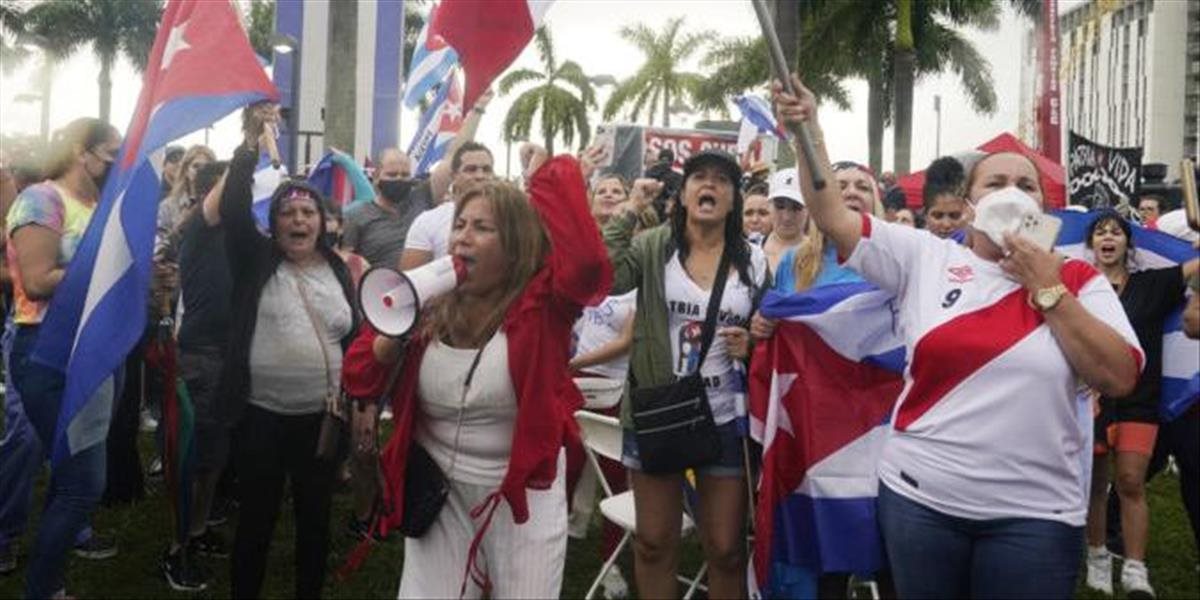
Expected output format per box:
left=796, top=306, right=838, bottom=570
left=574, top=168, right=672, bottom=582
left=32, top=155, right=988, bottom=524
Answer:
left=878, top=482, right=1084, bottom=599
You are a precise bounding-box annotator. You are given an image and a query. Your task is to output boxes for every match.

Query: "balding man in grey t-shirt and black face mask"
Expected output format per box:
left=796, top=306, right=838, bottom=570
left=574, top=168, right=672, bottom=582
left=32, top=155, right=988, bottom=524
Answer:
left=343, top=148, right=433, bottom=269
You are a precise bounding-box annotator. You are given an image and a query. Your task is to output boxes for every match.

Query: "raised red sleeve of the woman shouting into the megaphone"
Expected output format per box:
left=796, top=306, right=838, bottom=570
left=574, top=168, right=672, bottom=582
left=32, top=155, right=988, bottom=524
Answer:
left=529, top=156, right=612, bottom=306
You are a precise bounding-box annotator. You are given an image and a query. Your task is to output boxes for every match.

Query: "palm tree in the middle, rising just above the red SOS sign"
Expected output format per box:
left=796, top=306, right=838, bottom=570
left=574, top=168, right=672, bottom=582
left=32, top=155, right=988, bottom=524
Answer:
left=604, top=17, right=713, bottom=127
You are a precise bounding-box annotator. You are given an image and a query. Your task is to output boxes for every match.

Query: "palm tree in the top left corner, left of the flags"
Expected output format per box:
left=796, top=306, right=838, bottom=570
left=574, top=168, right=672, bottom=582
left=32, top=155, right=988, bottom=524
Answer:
left=25, top=0, right=162, bottom=121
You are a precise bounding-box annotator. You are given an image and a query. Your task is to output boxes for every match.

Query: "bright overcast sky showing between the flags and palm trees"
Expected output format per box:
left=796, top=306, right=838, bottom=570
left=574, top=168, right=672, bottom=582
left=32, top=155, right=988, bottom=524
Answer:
left=0, top=0, right=1089, bottom=173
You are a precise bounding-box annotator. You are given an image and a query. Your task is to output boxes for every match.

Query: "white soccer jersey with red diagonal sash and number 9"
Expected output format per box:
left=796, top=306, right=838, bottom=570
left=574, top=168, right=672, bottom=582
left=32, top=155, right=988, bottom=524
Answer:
left=846, top=216, right=1145, bottom=527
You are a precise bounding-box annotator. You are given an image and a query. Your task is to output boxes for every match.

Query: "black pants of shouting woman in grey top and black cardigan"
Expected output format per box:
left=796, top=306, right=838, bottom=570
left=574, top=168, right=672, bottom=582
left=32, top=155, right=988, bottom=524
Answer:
left=232, top=406, right=334, bottom=598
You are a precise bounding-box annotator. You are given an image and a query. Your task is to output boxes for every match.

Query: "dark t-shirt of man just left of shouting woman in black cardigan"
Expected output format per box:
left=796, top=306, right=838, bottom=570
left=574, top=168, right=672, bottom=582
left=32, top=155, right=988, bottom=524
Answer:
left=179, top=210, right=233, bottom=349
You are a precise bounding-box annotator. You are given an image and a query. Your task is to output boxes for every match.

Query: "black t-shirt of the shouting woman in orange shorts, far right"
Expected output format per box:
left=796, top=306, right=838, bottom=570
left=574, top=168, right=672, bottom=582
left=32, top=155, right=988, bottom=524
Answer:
left=1102, top=266, right=1184, bottom=422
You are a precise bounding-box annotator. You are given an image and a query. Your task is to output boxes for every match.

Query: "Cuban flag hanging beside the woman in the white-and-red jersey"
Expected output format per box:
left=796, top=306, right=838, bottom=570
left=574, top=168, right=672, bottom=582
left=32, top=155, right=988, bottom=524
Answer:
left=748, top=282, right=905, bottom=598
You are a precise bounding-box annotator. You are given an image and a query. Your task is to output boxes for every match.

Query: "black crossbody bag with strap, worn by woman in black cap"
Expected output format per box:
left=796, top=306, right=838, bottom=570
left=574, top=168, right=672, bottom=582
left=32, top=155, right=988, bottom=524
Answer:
left=630, top=250, right=730, bottom=474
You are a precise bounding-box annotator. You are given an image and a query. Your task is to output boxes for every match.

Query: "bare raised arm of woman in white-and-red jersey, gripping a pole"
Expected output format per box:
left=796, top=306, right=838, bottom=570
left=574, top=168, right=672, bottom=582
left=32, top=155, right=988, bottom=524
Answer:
left=772, top=76, right=863, bottom=257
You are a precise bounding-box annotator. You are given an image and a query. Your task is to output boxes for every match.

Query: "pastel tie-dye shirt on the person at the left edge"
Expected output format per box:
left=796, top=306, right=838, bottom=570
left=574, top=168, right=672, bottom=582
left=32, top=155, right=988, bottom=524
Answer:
left=6, top=181, right=95, bottom=325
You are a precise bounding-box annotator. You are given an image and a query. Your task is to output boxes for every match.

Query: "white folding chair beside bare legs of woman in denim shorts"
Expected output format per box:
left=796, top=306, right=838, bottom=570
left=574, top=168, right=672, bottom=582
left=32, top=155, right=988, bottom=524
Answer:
left=575, top=410, right=708, bottom=600
